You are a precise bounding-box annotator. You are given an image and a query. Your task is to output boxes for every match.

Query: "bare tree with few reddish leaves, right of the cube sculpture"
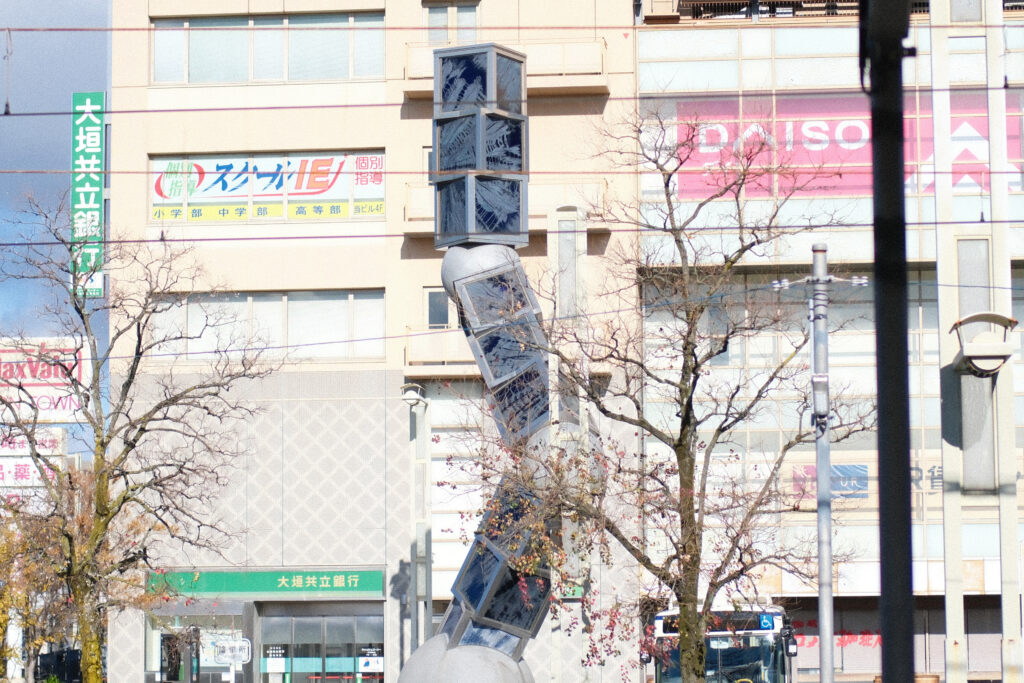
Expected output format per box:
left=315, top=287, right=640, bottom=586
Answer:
left=460, top=112, right=873, bottom=682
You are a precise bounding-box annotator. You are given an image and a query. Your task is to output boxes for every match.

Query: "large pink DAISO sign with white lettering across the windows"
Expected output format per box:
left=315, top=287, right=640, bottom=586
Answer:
left=675, top=90, right=1024, bottom=199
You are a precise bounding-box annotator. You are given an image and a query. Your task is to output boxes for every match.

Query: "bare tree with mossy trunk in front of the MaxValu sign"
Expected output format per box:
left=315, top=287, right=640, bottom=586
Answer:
left=0, top=193, right=273, bottom=683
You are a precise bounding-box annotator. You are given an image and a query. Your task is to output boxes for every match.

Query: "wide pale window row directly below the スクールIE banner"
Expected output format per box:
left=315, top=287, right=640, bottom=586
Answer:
left=154, top=290, right=385, bottom=359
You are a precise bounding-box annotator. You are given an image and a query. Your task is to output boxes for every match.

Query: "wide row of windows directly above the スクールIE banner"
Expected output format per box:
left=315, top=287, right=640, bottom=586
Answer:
left=153, top=12, right=384, bottom=84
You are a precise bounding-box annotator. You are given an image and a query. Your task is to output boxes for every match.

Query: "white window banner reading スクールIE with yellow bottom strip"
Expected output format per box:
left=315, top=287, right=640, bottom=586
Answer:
left=150, top=151, right=384, bottom=222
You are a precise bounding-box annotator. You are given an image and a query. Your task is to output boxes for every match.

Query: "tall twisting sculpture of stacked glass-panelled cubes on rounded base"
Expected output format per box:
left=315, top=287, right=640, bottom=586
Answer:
left=399, top=43, right=577, bottom=683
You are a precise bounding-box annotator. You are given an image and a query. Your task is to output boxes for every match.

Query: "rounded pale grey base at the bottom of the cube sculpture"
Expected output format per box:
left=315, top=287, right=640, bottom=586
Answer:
left=398, top=633, right=535, bottom=683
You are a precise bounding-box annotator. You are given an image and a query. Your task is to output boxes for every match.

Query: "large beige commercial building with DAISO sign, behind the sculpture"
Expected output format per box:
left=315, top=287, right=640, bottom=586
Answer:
left=109, top=0, right=1024, bottom=683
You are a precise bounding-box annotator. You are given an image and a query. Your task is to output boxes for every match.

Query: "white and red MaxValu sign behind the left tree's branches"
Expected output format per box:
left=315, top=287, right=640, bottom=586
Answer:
left=0, top=339, right=92, bottom=423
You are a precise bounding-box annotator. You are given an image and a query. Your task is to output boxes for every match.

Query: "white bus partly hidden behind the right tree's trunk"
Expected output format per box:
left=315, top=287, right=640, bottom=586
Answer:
left=654, top=605, right=797, bottom=683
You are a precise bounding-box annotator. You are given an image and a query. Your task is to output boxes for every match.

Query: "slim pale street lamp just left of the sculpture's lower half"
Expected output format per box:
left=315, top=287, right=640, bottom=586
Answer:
left=400, top=382, right=433, bottom=653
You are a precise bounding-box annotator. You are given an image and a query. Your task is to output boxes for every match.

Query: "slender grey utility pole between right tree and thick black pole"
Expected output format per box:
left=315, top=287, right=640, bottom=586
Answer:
left=809, top=244, right=835, bottom=683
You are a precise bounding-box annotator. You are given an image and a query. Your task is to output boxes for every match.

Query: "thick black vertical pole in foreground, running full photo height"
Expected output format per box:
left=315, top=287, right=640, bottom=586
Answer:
left=861, top=6, right=913, bottom=683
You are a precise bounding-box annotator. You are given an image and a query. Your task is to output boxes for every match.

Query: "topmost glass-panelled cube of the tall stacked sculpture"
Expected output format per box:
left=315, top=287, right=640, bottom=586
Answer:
left=434, top=43, right=526, bottom=118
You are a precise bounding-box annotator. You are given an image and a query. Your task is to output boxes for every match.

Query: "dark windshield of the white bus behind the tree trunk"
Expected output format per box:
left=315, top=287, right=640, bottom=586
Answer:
left=657, top=634, right=785, bottom=683
